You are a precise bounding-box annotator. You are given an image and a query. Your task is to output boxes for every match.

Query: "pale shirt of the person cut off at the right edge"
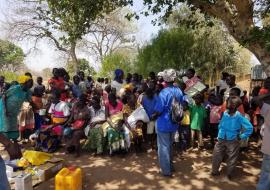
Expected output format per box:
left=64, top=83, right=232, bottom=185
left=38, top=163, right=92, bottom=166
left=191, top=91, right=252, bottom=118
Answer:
left=261, top=103, right=270, bottom=155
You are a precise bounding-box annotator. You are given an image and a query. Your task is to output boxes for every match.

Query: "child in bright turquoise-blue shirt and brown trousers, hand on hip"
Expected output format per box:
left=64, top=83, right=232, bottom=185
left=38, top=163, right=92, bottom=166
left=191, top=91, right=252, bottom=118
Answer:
left=212, top=96, right=253, bottom=180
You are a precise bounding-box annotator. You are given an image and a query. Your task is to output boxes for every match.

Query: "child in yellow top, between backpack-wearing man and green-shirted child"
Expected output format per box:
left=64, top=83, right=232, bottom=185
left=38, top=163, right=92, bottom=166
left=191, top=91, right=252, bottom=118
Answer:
left=179, top=101, right=190, bottom=151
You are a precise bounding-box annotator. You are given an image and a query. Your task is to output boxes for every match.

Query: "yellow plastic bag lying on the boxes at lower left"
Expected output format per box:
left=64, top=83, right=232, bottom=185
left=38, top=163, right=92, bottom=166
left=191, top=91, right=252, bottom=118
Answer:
left=23, top=150, right=52, bottom=166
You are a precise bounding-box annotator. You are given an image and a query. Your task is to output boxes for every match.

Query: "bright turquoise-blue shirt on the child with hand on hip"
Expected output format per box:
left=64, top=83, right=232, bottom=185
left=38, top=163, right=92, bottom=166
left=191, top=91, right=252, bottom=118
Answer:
left=218, top=111, right=253, bottom=140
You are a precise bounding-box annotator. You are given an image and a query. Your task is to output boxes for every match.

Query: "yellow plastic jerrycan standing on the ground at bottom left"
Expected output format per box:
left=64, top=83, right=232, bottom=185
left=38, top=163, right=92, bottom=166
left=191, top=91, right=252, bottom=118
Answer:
left=55, top=167, right=82, bottom=190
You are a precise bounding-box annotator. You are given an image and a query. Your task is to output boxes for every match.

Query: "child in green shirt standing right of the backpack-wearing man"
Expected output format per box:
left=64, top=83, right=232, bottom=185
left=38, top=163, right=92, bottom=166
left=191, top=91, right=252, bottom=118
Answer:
left=189, top=94, right=207, bottom=148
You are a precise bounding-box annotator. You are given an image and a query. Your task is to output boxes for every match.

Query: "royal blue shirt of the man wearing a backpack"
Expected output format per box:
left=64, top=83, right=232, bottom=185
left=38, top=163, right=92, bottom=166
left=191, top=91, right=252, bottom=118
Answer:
left=155, top=86, right=183, bottom=133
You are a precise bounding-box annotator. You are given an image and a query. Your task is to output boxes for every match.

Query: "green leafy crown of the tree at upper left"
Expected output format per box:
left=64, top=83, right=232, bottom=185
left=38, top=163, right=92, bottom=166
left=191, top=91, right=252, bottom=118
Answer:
left=42, top=0, right=133, bottom=43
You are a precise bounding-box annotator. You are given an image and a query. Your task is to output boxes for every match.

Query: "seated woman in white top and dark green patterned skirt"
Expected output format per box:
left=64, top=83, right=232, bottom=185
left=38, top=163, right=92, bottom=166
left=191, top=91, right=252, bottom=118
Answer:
left=83, top=96, right=106, bottom=154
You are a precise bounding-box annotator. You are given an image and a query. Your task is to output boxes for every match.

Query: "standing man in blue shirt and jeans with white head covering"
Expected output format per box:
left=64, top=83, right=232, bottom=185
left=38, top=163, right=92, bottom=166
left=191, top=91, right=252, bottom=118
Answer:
left=154, top=69, right=183, bottom=177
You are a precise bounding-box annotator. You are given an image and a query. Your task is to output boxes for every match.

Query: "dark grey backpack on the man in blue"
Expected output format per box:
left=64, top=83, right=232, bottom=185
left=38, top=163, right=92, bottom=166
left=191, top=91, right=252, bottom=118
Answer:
left=170, top=96, right=184, bottom=124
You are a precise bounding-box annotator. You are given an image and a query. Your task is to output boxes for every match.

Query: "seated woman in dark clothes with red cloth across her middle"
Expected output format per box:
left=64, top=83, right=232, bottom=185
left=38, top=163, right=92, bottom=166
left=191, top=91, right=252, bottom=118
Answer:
left=64, top=94, right=90, bottom=156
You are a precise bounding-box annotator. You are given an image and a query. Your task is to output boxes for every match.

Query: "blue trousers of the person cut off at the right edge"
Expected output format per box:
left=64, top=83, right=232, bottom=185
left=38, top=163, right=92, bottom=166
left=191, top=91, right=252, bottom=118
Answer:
left=257, top=154, right=270, bottom=190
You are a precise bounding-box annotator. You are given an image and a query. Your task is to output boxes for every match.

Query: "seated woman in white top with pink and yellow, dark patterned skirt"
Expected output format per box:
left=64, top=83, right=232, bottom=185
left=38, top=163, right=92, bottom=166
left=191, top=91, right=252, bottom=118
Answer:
left=36, top=91, right=70, bottom=152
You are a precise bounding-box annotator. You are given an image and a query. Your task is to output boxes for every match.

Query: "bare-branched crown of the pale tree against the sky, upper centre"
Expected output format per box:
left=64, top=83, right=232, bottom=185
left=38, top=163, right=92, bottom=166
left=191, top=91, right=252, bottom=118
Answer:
left=80, top=9, right=136, bottom=63
